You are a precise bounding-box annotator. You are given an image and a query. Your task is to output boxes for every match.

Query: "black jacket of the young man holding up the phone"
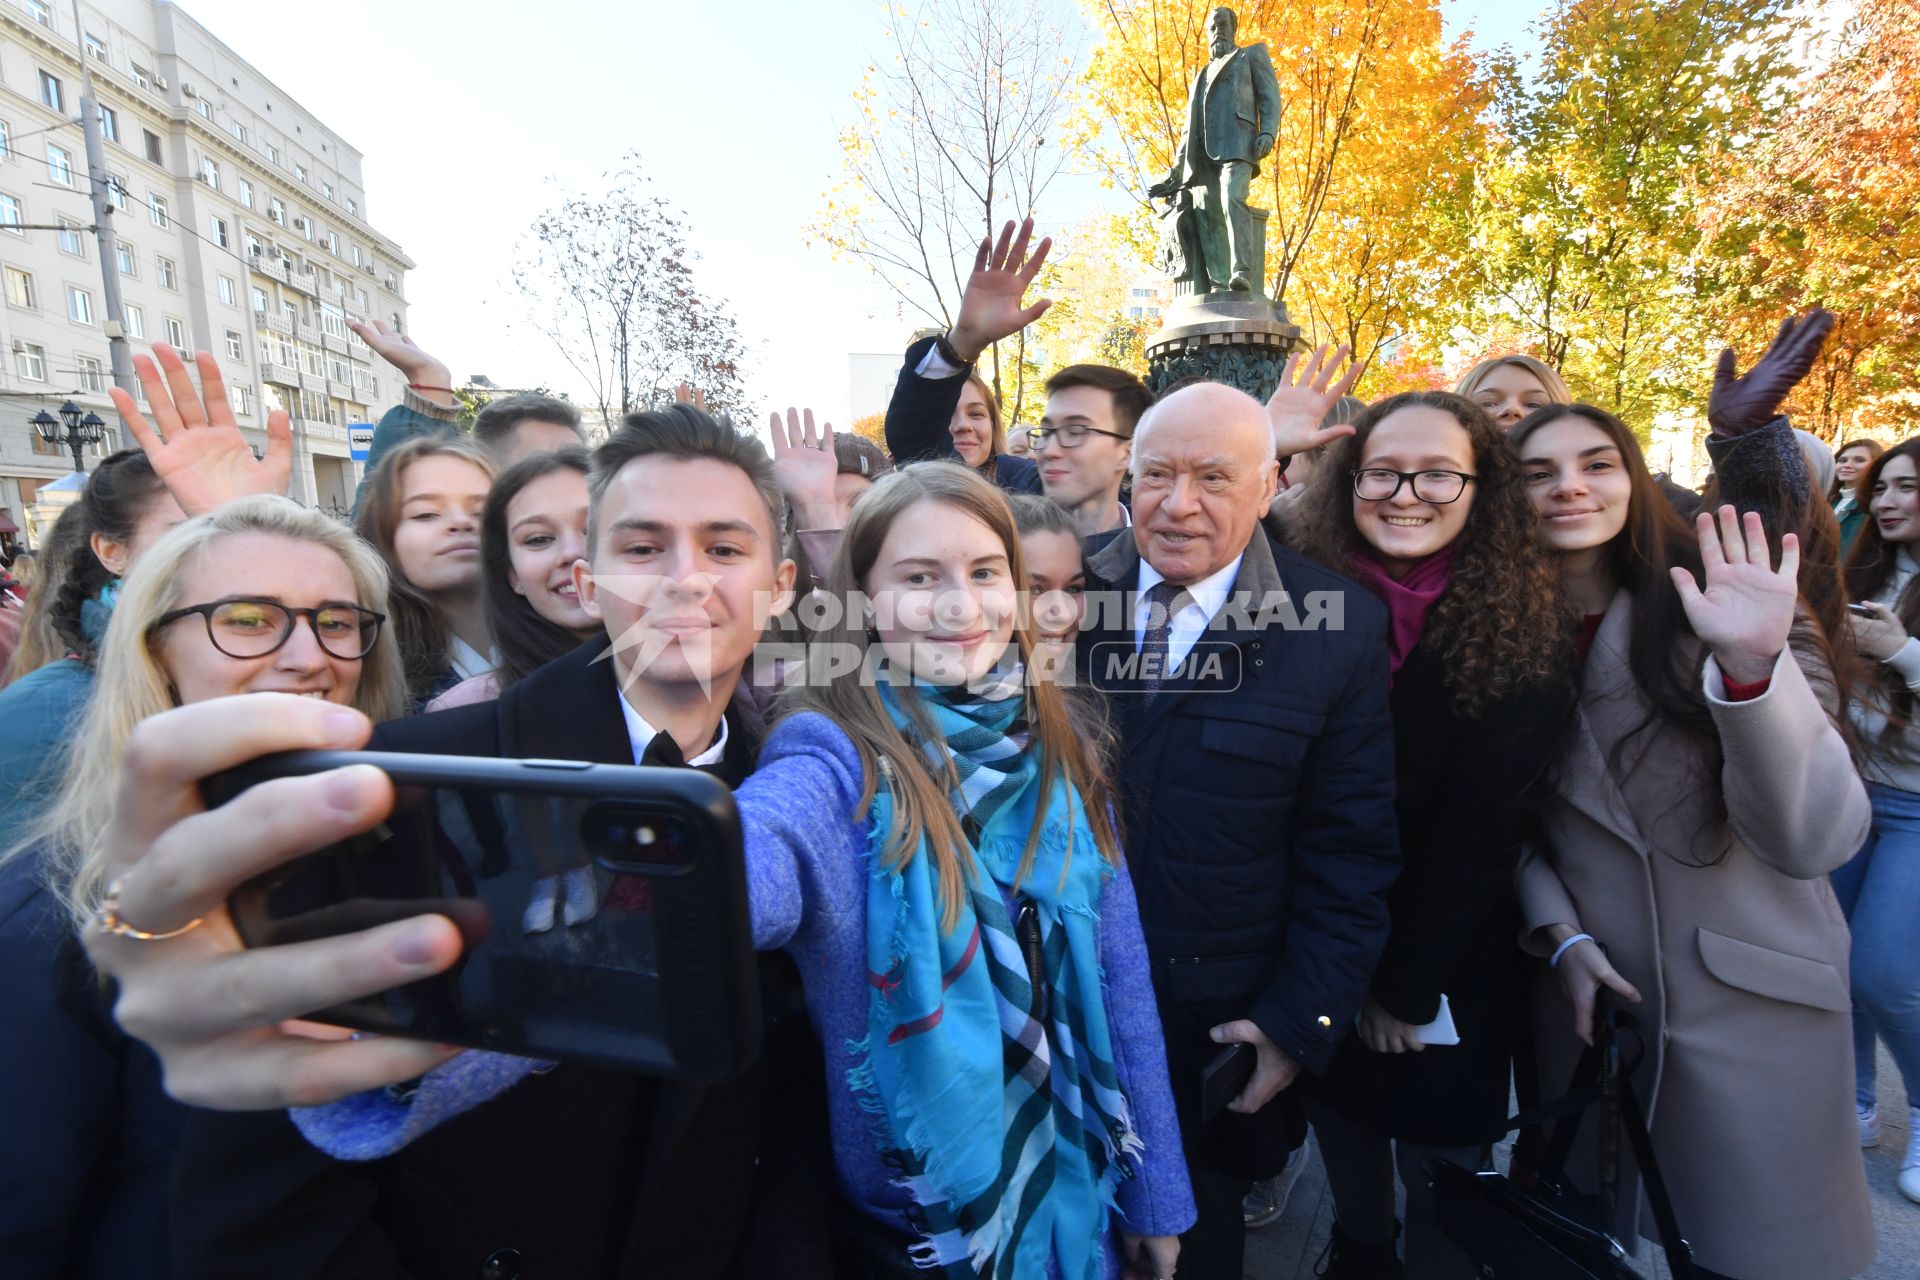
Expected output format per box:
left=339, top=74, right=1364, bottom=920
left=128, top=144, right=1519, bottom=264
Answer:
left=173, top=639, right=831, bottom=1280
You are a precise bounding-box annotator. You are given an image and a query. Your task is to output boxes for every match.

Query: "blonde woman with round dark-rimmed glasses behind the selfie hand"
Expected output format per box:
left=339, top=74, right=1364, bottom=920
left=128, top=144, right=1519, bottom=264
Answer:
left=0, top=497, right=405, bottom=1276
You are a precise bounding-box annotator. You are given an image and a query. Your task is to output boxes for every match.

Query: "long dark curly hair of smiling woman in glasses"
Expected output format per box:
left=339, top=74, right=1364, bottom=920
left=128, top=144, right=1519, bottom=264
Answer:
left=1288, top=391, right=1572, bottom=716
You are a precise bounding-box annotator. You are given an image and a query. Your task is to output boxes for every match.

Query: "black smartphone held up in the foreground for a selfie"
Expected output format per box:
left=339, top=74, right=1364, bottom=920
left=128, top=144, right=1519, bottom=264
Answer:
left=202, top=752, right=762, bottom=1080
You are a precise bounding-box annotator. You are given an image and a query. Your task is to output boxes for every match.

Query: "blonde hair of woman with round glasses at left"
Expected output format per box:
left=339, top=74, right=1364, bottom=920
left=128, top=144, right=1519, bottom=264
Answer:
left=0, top=495, right=405, bottom=929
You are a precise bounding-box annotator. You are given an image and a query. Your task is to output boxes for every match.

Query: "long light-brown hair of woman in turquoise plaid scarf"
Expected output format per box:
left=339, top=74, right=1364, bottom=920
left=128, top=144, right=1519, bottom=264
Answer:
left=783, top=462, right=1119, bottom=931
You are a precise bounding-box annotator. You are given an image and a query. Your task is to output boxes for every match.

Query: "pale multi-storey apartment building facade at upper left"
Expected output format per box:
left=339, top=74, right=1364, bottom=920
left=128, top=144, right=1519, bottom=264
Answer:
left=0, top=0, right=413, bottom=541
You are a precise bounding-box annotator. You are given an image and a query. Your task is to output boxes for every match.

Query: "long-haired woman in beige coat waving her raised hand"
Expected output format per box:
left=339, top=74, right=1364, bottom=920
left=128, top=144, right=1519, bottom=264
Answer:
left=1507, top=405, right=1874, bottom=1280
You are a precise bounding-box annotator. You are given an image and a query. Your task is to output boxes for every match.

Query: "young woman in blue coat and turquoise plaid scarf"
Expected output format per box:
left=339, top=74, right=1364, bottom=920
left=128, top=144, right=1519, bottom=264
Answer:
left=296, top=462, right=1194, bottom=1280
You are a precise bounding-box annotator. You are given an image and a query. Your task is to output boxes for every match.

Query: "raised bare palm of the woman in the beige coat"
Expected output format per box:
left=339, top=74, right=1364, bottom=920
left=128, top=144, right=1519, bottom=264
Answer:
left=1670, top=507, right=1799, bottom=685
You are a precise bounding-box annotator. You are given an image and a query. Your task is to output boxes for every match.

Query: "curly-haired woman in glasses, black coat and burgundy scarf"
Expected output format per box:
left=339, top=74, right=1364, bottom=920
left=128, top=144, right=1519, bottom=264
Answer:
left=1290, top=391, right=1572, bottom=1276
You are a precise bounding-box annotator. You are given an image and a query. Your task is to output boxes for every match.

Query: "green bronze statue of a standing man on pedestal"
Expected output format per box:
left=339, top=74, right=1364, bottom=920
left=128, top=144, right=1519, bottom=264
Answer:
left=1146, top=6, right=1281, bottom=294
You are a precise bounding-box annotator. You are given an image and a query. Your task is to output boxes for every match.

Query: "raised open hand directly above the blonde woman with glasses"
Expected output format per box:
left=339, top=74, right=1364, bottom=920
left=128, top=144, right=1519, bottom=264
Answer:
left=108, top=342, right=294, bottom=516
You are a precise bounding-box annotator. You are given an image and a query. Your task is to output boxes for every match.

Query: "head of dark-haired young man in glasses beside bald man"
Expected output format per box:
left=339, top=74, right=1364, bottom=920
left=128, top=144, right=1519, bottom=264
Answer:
left=1027, top=365, right=1154, bottom=555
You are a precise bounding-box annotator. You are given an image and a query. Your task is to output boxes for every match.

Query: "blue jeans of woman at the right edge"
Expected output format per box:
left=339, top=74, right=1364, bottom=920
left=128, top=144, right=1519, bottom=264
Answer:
left=1834, top=783, right=1920, bottom=1107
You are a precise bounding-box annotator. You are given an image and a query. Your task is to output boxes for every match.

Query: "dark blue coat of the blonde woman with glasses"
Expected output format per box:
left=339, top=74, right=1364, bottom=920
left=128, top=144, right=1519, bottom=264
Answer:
left=0, top=854, right=186, bottom=1280
